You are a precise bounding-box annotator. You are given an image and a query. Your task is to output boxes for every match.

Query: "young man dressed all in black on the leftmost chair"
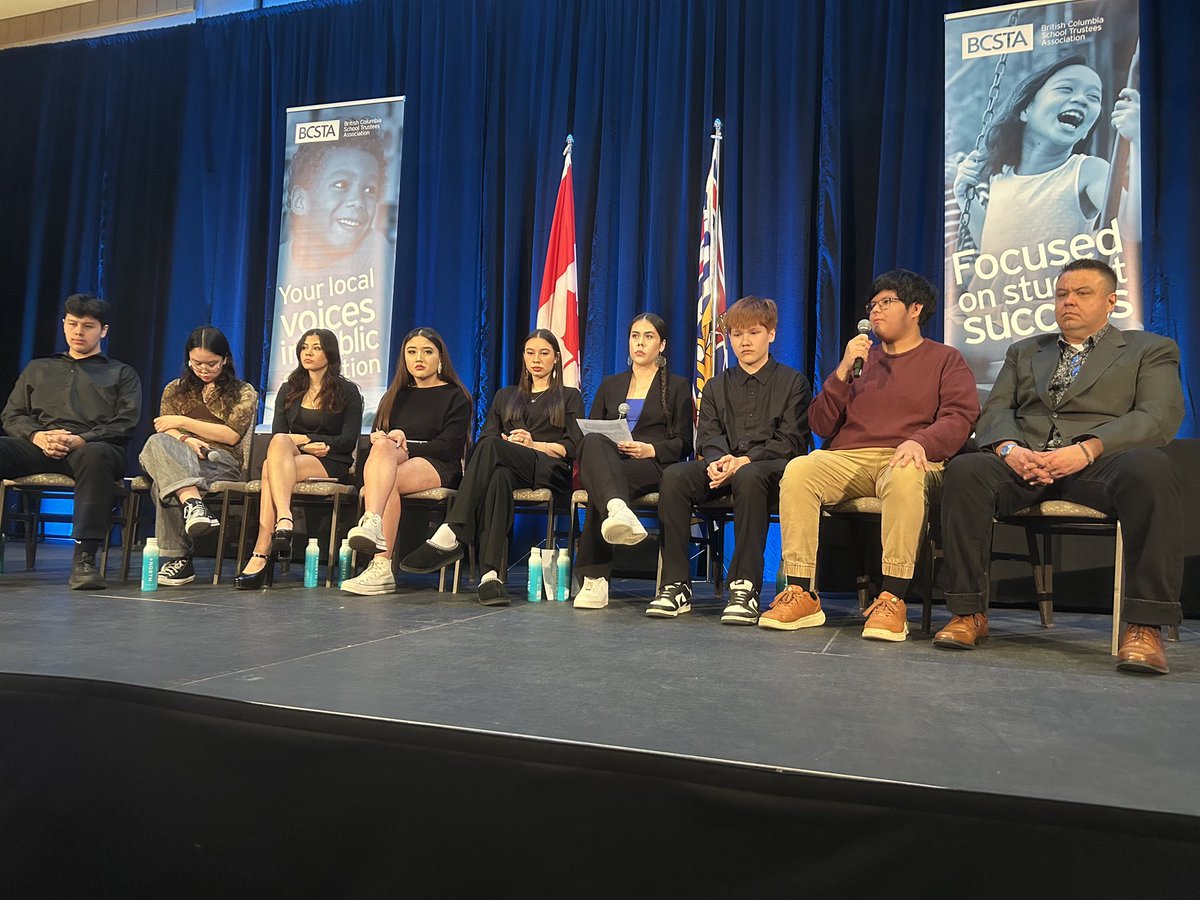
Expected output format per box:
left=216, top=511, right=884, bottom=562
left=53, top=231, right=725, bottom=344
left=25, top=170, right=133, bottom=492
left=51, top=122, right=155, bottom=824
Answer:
left=0, top=294, right=142, bottom=590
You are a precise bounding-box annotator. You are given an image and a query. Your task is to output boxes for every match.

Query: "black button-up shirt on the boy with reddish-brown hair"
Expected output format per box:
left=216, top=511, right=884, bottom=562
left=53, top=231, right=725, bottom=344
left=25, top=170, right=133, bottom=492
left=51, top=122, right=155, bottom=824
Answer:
left=696, top=358, right=812, bottom=462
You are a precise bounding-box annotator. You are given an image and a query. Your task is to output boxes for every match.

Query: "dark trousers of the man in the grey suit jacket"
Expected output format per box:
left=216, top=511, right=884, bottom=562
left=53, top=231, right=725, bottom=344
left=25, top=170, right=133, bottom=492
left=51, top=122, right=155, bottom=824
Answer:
left=941, top=448, right=1183, bottom=625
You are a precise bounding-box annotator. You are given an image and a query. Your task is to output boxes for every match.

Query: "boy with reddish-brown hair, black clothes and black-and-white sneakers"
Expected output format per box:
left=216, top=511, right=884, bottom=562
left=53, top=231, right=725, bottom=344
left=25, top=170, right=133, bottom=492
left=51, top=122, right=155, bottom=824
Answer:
left=646, top=296, right=812, bottom=625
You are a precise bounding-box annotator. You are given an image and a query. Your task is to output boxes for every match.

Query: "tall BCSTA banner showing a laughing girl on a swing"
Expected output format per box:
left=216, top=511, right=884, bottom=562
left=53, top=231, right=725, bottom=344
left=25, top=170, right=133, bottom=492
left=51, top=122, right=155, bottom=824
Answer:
left=944, top=0, right=1142, bottom=394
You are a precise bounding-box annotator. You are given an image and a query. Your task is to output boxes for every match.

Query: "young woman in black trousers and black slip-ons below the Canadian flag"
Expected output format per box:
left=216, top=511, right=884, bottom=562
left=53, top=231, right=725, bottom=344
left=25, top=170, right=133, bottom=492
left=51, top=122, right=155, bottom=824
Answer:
left=400, top=329, right=583, bottom=606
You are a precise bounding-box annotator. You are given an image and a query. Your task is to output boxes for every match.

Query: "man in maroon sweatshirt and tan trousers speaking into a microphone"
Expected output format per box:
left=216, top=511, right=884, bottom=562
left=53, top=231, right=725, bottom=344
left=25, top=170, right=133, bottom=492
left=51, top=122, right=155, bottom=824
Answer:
left=758, top=269, right=979, bottom=641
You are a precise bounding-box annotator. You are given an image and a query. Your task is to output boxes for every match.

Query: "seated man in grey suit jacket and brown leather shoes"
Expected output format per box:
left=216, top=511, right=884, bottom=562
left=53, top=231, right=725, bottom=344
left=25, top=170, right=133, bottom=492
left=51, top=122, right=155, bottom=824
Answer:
left=934, top=259, right=1183, bottom=673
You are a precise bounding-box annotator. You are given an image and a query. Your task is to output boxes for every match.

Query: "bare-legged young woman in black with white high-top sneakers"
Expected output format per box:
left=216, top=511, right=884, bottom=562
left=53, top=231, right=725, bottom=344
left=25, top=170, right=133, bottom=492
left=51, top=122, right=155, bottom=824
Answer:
left=342, top=328, right=472, bottom=595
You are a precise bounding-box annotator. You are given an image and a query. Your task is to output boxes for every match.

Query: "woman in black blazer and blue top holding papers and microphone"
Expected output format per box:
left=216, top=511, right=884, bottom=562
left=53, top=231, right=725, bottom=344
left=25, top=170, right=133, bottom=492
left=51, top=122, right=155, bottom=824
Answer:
left=575, top=312, right=692, bottom=610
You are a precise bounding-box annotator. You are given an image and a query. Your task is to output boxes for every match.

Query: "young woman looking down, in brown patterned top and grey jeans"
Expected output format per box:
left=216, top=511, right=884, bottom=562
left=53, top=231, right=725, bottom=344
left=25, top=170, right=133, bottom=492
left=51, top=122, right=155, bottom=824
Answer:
left=138, top=325, right=258, bottom=587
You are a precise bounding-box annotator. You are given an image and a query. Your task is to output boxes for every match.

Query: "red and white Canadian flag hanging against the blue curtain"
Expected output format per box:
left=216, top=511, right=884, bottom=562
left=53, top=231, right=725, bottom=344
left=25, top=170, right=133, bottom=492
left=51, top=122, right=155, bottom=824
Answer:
left=538, top=134, right=580, bottom=388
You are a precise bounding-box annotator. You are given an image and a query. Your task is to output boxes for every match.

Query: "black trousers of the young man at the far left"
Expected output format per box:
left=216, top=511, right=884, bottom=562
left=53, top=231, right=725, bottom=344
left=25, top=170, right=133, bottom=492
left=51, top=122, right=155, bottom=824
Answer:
left=0, top=437, right=125, bottom=541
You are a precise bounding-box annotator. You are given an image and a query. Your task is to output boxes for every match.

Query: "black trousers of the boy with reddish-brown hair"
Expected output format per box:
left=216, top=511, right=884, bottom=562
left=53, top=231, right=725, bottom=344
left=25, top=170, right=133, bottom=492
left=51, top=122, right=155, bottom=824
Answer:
left=659, top=460, right=787, bottom=588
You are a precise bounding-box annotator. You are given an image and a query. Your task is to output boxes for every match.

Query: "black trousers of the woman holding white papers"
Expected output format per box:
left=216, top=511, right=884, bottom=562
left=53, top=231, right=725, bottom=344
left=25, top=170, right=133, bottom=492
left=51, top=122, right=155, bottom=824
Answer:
left=575, top=434, right=662, bottom=578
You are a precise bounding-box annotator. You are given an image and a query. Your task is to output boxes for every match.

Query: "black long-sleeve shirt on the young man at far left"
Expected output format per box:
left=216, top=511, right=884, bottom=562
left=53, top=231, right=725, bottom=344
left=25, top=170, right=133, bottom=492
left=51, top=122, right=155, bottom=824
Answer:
left=0, top=353, right=142, bottom=446
